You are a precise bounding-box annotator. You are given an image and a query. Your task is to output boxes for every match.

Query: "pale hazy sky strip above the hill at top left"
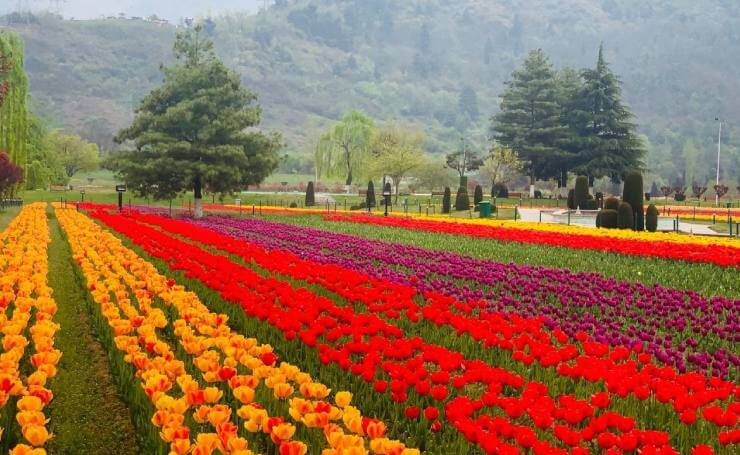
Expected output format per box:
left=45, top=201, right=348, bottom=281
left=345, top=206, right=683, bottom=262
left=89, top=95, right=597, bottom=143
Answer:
left=0, top=0, right=264, bottom=21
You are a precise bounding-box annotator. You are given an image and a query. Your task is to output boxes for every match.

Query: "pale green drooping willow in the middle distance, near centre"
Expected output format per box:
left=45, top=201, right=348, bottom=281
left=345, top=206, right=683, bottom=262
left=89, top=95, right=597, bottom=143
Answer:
left=314, top=111, right=375, bottom=185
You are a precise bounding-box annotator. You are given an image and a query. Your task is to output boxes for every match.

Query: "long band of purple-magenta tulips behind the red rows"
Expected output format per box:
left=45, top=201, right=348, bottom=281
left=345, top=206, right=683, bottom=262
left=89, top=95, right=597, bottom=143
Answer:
left=186, top=216, right=740, bottom=378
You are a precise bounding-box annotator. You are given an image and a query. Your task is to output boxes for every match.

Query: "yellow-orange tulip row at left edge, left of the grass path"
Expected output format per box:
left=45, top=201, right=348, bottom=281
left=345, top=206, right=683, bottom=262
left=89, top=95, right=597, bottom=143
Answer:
left=0, top=204, right=62, bottom=455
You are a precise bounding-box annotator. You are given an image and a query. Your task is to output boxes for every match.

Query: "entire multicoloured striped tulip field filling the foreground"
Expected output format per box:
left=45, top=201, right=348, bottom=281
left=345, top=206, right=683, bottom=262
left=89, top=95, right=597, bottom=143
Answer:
left=0, top=203, right=740, bottom=455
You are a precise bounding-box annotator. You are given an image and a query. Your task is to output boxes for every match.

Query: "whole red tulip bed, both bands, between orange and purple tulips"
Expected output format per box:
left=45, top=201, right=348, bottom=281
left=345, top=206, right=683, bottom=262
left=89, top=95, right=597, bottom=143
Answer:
left=84, top=208, right=738, bottom=453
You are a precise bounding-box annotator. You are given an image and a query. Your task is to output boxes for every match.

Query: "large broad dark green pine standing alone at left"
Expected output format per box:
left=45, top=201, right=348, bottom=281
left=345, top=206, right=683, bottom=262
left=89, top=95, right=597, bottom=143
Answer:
left=111, top=26, right=282, bottom=217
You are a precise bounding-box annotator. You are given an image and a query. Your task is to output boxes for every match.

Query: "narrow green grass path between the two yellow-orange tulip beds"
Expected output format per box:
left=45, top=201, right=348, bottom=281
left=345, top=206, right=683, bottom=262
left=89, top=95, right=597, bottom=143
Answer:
left=47, top=211, right=140, bottom=455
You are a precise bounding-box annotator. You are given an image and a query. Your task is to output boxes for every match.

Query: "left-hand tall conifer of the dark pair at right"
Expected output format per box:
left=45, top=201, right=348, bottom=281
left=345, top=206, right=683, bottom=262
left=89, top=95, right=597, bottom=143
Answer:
left=491, top=49, right=567, bottom=197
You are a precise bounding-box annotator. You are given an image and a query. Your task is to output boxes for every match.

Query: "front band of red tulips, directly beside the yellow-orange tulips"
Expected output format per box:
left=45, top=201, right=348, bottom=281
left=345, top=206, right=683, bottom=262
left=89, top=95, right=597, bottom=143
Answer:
left=88, top=208, right=734, bottom=453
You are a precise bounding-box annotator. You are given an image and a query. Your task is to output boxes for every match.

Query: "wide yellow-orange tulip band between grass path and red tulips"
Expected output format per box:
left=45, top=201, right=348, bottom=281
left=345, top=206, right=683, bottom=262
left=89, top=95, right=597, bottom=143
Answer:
left=57, top=207, right=418, bottom=455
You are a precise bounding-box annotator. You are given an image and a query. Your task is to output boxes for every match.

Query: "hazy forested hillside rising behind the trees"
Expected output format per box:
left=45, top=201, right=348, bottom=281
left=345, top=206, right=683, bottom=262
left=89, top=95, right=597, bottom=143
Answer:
left=4, top=0, right=740, bottom=185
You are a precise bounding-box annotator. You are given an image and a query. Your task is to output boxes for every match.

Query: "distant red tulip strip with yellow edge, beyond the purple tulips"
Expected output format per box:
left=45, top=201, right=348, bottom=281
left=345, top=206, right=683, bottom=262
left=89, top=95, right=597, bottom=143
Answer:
left=324, top=214, right=740, bottom=267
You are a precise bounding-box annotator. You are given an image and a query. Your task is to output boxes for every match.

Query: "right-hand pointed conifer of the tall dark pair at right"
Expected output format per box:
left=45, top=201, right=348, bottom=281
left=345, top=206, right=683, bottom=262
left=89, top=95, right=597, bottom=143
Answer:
left=568, top=46, right=645, bottom=182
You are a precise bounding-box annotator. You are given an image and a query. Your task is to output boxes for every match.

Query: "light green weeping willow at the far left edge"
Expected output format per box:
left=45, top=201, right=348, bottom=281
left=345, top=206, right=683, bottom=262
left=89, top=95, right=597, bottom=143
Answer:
left=0, top=32, right=29, bottom=166
